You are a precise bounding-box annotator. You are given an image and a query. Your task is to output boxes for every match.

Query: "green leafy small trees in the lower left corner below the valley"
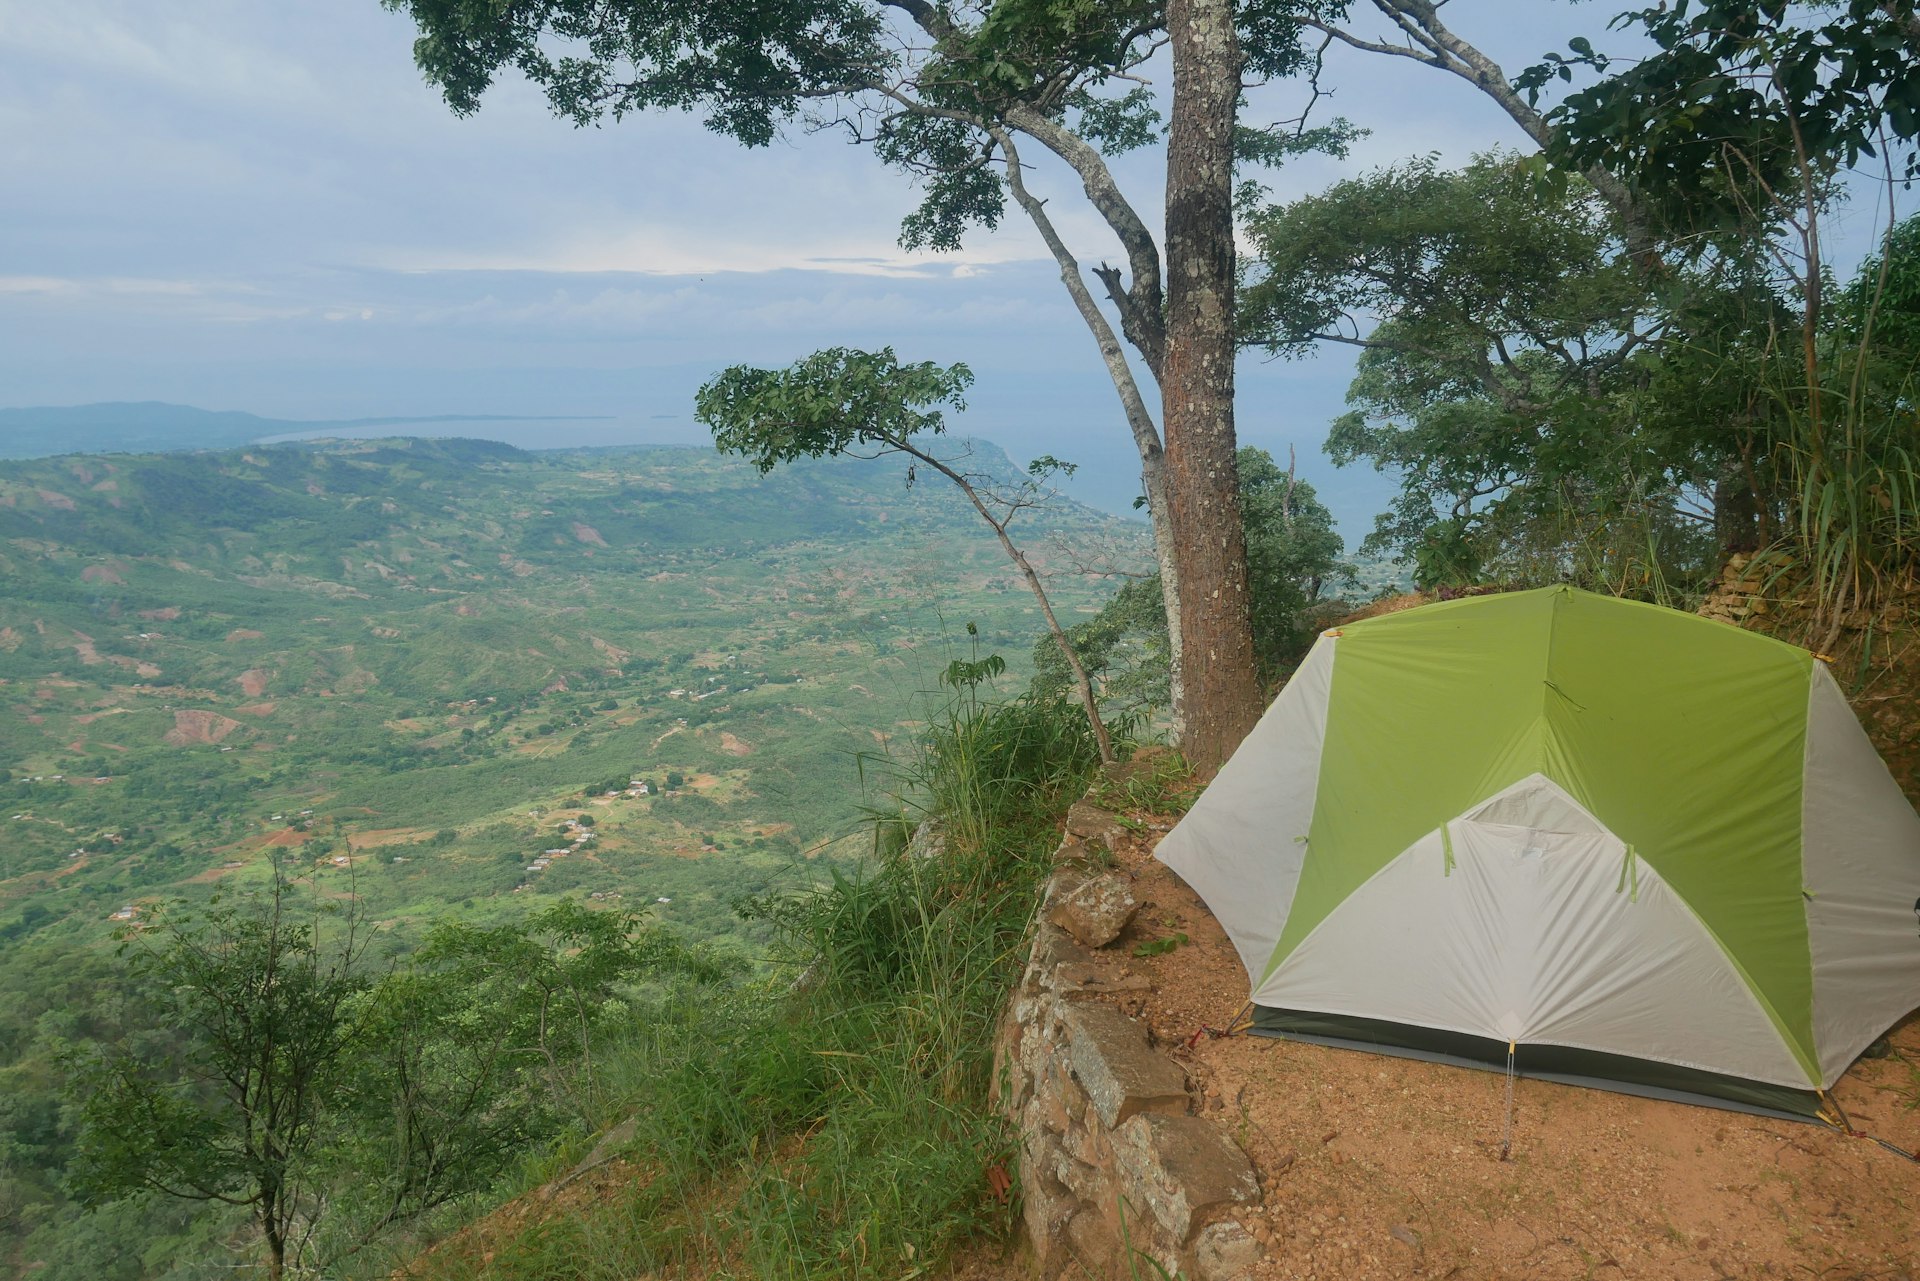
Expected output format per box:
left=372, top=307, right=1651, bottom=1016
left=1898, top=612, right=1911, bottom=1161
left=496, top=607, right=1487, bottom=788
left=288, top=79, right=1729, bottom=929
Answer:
left=71, top=876, right=724, bottom=1275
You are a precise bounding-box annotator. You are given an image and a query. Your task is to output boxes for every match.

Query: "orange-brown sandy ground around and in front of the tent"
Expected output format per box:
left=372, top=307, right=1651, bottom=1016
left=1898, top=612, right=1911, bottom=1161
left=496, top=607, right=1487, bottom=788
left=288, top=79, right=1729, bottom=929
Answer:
left=1098, top=783, right=1920, bottom=1281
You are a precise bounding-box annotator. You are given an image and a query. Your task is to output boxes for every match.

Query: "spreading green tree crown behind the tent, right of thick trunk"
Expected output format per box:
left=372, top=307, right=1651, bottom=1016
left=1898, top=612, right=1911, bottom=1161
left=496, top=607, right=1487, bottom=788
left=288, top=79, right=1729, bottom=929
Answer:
left=1242, top=152, right=1718, bottom=586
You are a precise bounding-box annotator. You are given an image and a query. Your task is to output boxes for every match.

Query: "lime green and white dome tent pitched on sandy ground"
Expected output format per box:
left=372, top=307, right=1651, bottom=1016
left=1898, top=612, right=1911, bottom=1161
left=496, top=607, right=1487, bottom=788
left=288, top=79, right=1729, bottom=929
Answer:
left=1160, top=588, right=1920, bottom=1114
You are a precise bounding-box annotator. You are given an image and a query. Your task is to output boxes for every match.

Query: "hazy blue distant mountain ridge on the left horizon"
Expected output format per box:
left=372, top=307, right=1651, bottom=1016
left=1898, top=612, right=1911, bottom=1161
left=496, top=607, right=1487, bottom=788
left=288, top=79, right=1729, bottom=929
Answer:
left=0, top=399, right=599, bottom=459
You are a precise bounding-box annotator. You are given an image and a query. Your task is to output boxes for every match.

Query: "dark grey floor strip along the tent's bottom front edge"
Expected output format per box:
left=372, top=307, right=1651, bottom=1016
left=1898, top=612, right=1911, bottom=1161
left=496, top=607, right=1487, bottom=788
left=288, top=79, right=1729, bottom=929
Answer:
left=1248, top=1004, right=1826, bottom=1125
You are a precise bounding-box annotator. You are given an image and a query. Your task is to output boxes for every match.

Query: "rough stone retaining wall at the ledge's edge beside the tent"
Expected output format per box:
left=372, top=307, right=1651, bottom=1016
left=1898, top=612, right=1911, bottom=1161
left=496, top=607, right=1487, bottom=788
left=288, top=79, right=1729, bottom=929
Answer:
left=995, top=775, right=1261, bottom=1281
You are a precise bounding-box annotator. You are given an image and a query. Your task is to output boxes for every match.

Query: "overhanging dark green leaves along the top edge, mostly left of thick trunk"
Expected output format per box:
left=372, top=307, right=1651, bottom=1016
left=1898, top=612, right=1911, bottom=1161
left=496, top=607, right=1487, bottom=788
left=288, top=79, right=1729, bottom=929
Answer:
left=382, top=0, right=1346, bottom=261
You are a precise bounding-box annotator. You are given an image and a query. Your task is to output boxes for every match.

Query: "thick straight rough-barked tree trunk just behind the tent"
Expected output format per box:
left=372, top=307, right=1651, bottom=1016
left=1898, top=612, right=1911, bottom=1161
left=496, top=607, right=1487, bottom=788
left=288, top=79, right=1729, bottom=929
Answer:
left=1160, top=0, right=1261, bottom=772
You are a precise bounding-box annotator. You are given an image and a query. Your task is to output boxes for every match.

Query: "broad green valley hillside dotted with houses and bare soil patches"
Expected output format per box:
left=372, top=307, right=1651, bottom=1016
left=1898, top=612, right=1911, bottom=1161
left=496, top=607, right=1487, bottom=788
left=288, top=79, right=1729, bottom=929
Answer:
left=0, top=440, right=1140, bottom=1275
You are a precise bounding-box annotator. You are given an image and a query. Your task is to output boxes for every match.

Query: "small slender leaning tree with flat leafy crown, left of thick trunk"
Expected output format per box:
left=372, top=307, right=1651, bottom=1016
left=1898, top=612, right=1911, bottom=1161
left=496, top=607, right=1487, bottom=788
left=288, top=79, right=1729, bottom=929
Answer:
left=695, top=348, right=1114, bottom=762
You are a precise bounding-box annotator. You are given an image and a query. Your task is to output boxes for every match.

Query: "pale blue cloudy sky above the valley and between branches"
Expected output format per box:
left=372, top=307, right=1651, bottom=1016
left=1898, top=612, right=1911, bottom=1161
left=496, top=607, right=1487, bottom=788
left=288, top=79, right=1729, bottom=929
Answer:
left=0, top=0, right=1889, bottom=540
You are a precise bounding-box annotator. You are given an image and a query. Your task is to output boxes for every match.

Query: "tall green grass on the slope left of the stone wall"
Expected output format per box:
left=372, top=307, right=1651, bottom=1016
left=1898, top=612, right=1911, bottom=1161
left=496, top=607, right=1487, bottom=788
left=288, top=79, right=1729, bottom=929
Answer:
left=395, top=682, right=1098, bottom=1281
